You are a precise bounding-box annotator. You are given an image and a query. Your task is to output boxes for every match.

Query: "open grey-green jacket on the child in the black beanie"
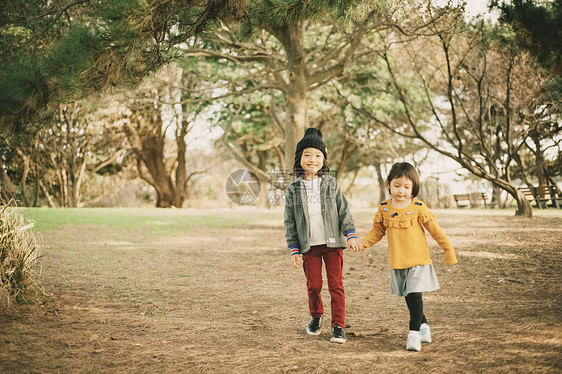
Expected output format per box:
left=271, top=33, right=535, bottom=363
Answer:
left=285, top=175, right=357, bottom=255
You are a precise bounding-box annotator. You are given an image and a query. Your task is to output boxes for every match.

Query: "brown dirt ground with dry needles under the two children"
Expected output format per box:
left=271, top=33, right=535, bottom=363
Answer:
left=0, top=209, right=562, bottom=373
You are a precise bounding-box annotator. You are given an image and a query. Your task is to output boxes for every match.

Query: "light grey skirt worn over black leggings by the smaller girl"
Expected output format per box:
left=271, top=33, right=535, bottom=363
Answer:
left=390, top=264, right=439, bottom=297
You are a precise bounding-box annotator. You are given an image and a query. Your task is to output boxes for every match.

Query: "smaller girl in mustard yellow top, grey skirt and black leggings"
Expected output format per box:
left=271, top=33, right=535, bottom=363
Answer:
left=354, top=162, right=457, bottom=351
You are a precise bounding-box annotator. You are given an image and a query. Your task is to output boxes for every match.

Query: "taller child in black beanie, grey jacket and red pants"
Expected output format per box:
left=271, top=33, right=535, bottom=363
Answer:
left=285, top=128, right=362, bottom=343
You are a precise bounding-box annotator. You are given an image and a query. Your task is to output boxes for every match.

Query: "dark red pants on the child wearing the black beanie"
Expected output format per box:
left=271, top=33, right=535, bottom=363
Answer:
left=303, top=245, right=345, bottom=328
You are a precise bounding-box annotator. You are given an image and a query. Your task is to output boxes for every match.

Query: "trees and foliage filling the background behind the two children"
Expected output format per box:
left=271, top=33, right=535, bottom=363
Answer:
left=0, top=0, right=562, bottom=215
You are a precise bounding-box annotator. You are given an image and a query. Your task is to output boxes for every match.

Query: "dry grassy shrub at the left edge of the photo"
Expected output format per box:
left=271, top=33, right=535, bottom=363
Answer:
left=0, top=203, right=40, bottom=309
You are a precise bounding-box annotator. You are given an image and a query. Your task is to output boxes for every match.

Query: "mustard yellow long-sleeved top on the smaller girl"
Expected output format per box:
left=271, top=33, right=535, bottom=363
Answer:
left=363, top=199, right=457, bottom=269
